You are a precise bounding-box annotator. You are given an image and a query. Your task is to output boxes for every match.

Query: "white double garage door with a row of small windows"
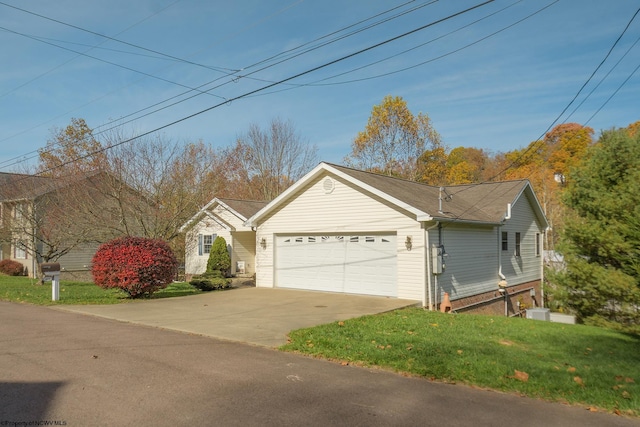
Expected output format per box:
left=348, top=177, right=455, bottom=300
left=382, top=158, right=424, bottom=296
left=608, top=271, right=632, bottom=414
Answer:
left=276, top=234, right=397, bottom=296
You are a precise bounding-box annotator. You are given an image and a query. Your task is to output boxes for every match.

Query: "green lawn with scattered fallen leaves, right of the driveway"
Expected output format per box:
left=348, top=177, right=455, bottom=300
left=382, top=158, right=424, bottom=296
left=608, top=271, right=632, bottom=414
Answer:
left=281, top=308, right=640, bottom=416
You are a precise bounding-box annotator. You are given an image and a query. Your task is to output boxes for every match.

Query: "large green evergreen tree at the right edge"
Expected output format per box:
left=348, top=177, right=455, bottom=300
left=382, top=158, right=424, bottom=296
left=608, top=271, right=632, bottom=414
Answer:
left=552, top=129, right=640, bottom=327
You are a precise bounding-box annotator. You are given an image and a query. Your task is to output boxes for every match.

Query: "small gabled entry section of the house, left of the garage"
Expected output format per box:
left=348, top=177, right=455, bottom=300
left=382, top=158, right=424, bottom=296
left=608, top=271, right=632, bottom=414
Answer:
left=180, top=198, right=267, bottom=278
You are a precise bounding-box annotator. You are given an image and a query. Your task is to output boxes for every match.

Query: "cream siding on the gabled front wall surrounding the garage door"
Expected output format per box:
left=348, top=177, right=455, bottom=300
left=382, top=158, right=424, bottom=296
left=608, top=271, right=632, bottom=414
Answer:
left=256, top=175, right=424, bottom=300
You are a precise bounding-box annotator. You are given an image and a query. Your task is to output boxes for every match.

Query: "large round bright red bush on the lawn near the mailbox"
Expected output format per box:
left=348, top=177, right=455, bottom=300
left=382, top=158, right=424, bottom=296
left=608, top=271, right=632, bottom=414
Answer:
left=91, top=237, right=178, bottom=298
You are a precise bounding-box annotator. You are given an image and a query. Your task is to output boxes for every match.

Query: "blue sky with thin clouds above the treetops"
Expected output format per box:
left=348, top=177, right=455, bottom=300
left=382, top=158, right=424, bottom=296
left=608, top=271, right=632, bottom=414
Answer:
left=0, top=0, right=640, bottom=171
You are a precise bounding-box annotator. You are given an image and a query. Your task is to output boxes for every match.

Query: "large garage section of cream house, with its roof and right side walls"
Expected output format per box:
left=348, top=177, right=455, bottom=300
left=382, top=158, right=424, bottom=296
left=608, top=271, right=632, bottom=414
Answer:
left=245, top=163, right=548, bottom=314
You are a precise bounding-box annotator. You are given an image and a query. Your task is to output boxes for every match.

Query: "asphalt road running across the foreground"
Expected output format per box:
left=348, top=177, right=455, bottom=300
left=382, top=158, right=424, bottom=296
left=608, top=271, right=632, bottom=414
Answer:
left=0, top=302, right=640, bottom=427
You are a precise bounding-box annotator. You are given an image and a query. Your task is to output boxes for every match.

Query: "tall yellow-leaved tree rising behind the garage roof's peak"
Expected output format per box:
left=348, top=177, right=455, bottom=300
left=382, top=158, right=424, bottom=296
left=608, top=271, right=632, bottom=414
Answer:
left=344, top=96, right=446, bottom=181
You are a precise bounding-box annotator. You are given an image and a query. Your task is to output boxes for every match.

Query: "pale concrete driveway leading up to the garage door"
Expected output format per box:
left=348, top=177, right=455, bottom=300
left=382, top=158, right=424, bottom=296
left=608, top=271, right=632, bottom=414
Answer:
left=56, top=288, right=419, bottom=347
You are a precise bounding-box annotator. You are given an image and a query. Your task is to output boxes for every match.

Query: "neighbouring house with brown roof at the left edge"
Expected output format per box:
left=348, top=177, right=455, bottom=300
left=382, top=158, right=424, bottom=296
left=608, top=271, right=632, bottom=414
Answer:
left=0, top=172, right=148, bottom=280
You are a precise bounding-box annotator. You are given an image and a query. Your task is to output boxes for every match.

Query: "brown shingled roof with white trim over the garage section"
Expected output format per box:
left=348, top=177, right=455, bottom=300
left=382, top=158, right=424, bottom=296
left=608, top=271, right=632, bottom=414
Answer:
left=247, top=162, right=548, bottom=227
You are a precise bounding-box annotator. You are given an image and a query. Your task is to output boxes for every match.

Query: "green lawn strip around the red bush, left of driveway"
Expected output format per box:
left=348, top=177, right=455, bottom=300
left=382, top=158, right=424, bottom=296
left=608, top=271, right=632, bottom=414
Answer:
left=0, top=275, right=201, bottom=305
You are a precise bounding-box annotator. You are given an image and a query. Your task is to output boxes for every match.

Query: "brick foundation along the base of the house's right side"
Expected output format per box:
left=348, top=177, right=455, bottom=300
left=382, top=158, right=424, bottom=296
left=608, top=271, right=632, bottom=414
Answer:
left=438, top=280, right=542, bottom=316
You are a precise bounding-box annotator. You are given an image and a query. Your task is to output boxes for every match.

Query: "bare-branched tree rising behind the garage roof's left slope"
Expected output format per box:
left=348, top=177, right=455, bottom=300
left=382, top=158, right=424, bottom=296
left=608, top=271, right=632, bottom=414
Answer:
left=232, top=119, right=317, bottom=200
